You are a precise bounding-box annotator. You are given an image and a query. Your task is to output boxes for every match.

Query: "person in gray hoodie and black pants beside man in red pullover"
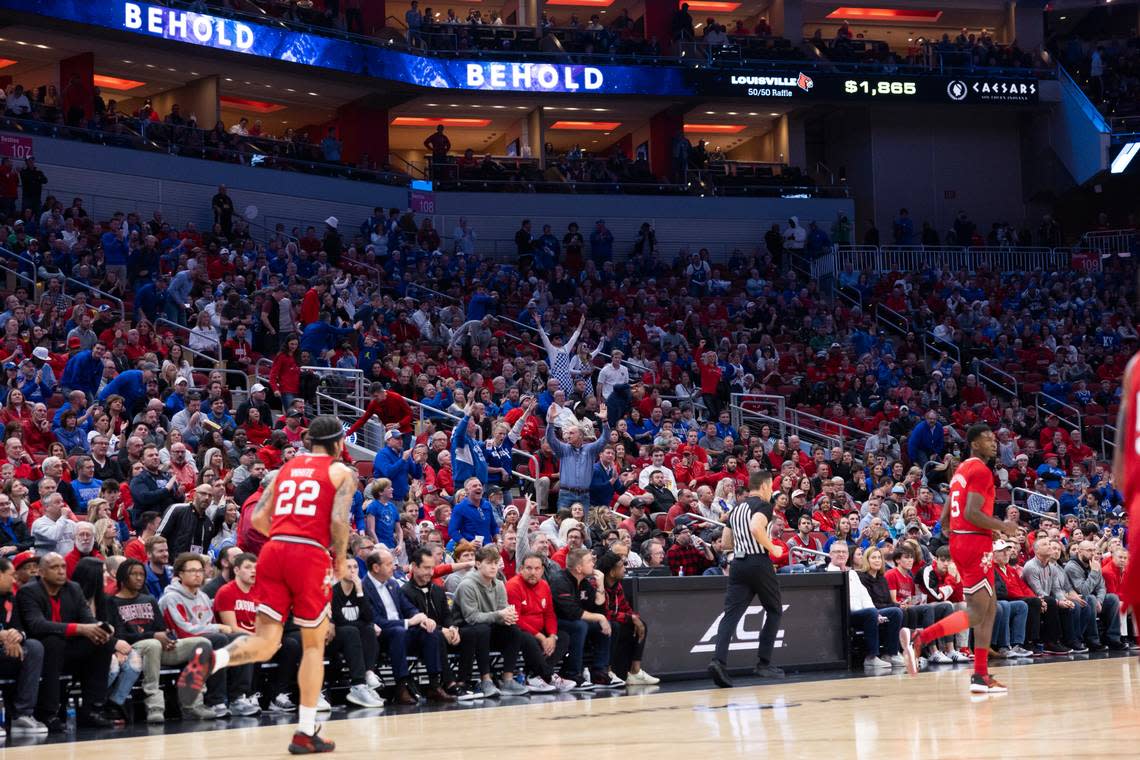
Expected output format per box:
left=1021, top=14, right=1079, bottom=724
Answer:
left=454, top=546, right=531, bottom=697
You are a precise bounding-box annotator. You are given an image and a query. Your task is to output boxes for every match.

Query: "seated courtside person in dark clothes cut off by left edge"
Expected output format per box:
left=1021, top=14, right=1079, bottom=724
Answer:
left=0, top=557, right=44, bottom=735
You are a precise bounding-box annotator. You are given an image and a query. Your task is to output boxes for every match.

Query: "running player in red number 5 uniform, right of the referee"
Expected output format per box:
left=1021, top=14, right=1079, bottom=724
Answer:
left=899, top=424, right=1017, bottom=694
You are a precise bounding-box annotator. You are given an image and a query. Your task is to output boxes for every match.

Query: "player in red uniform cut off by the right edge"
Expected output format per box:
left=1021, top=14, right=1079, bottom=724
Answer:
left=1113, top=353, right=1140, bottom=620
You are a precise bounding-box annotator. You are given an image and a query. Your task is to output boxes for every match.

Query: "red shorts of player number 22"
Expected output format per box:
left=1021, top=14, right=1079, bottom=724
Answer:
left=253, top=538, right=333, bottom=628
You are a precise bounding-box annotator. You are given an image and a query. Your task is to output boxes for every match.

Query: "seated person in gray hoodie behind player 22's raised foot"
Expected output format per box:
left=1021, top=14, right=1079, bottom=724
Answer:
left=158, top=551, right=261, bottom=718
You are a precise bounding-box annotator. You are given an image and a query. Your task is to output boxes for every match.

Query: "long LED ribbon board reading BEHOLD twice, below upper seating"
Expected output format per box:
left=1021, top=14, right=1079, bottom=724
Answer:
left=0, top=0, right=1037, bottom=104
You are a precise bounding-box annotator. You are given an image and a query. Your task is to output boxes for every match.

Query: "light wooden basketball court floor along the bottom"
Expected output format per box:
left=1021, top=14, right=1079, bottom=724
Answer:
left=11, top=656, right=1140, bottom=760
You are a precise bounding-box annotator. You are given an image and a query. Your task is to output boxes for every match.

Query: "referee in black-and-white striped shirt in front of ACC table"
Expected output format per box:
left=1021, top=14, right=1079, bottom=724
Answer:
left=709, top=471, right=784, bottom=688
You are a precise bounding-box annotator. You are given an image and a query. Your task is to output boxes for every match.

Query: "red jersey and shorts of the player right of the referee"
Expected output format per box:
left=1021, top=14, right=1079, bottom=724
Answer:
left=950, top=457, right=994, bottom=595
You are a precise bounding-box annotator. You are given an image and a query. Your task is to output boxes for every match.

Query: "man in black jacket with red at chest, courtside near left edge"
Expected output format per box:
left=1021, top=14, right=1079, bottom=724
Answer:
left=16, top=551, right=114, bottom=732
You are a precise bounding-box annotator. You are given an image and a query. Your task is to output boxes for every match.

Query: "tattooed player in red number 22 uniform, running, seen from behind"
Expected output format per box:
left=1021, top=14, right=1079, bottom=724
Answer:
left=178, top=415, right=357, bottom=754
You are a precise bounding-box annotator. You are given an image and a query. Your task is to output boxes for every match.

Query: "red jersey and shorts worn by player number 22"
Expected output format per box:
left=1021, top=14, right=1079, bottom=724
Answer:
left=253, top=453, right=336, bottom=628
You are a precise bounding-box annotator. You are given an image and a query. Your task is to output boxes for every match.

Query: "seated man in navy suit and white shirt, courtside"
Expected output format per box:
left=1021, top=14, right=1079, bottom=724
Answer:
left=364, top=548, right=455, bottom=704
